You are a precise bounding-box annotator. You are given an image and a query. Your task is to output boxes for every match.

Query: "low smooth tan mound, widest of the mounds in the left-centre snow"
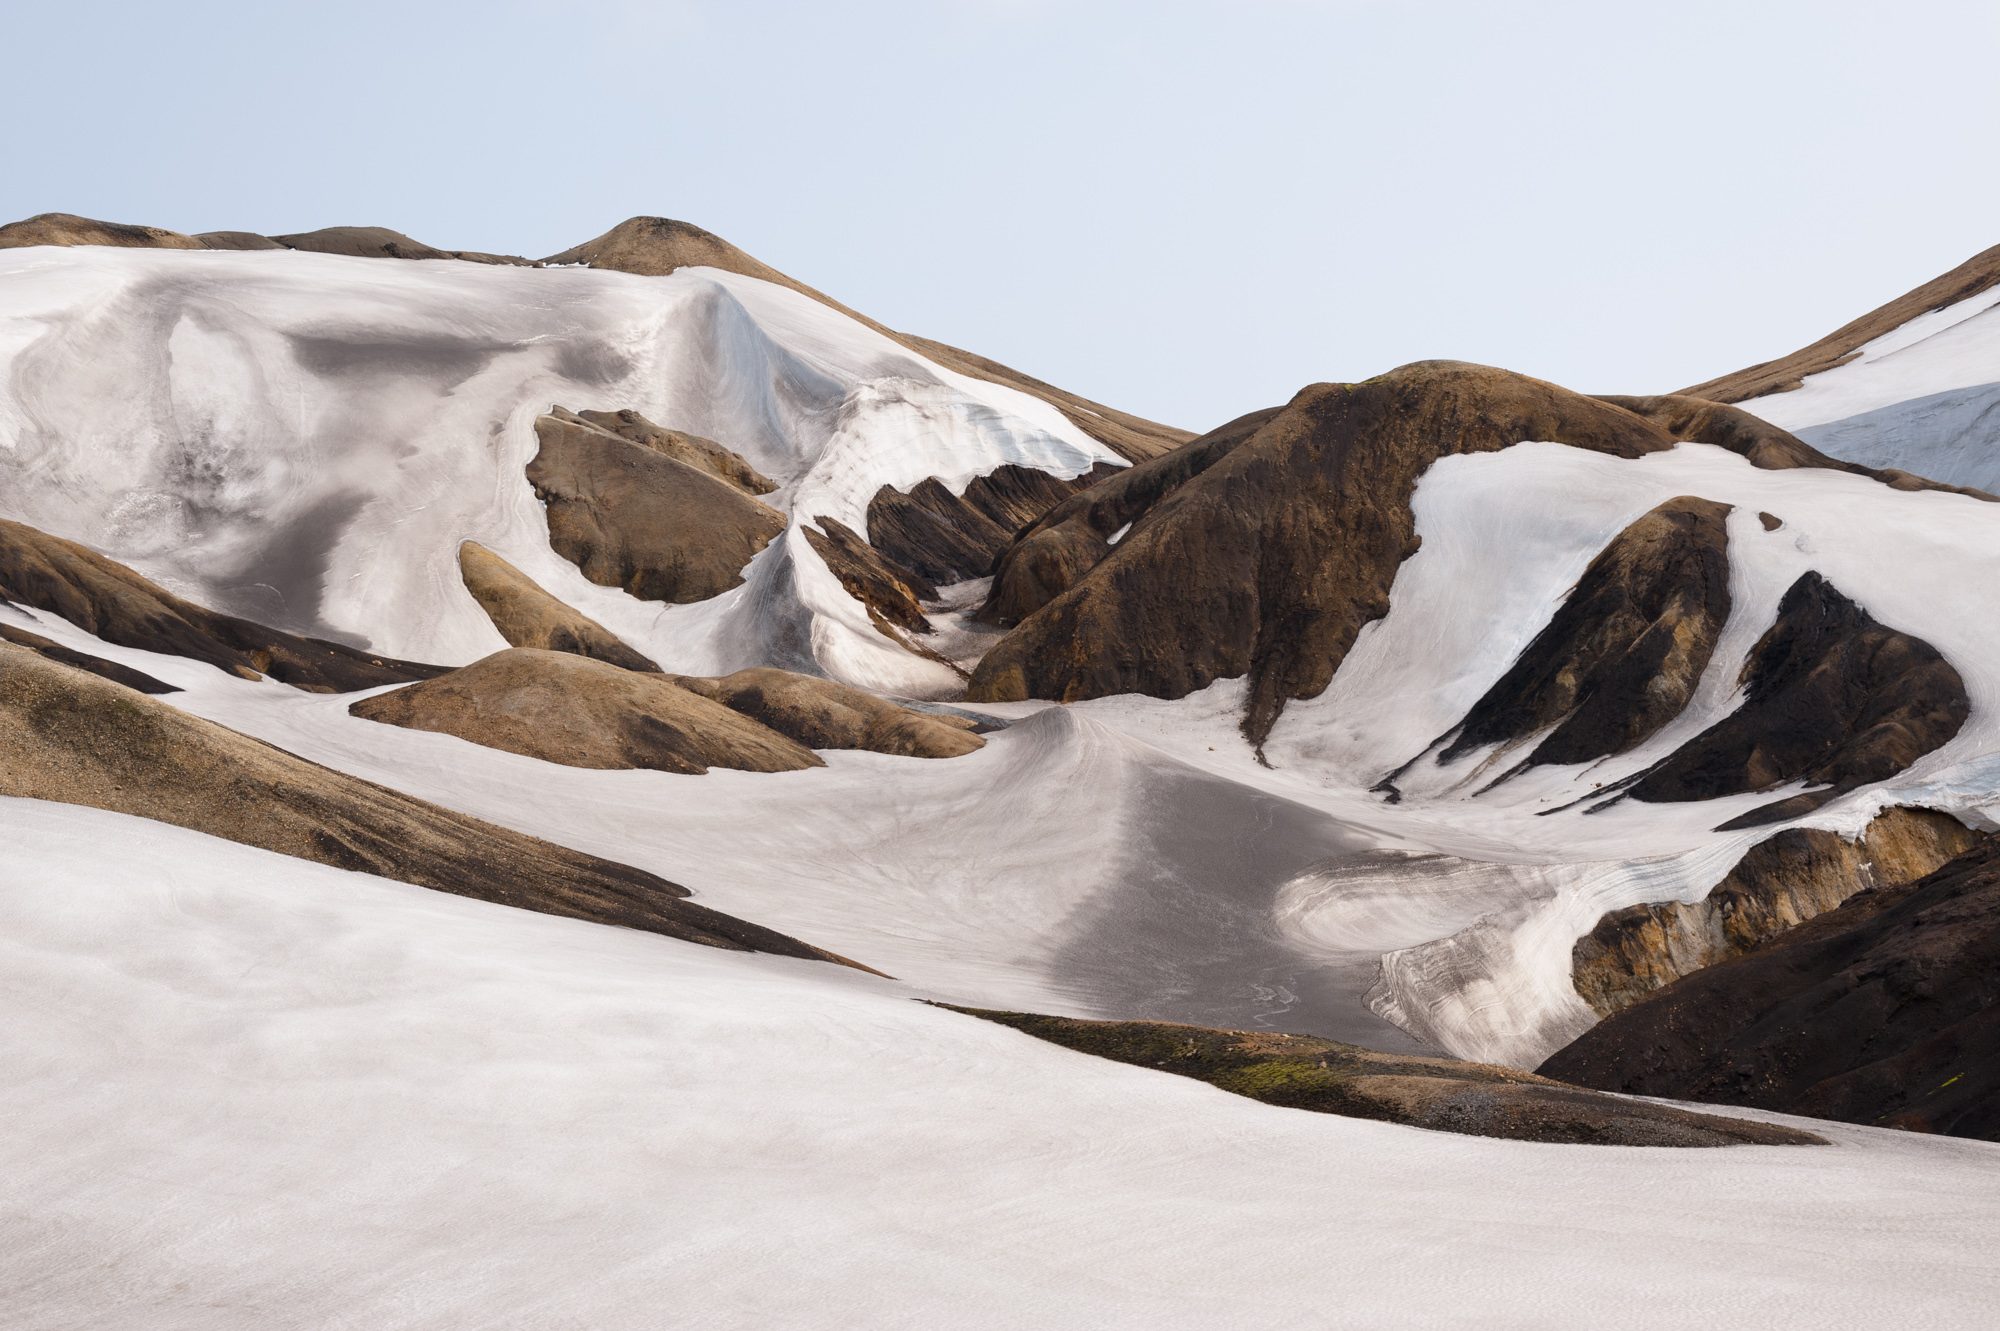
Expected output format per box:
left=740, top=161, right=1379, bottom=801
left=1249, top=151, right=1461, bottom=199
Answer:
left=348, top=648, right=824, bottom=773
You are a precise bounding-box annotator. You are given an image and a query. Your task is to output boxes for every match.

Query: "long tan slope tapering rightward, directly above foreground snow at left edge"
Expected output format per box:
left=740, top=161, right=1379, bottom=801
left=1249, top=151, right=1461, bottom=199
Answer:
left=0, top=646, right=840, bottom=961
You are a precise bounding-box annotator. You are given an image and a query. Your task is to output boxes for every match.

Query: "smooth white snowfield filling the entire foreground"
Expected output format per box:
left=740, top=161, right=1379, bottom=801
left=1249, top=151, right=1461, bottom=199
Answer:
left=0, top=799, right=2000, bottom=1331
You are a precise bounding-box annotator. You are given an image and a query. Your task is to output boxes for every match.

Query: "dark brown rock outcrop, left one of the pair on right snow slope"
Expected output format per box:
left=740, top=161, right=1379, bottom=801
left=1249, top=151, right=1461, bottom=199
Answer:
left=1438, top=496, right=1730, bottom=765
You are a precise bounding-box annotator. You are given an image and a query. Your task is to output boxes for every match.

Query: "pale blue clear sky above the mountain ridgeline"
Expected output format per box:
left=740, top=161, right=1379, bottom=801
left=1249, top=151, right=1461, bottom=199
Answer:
left=0, top=0, right=2000, bottom=430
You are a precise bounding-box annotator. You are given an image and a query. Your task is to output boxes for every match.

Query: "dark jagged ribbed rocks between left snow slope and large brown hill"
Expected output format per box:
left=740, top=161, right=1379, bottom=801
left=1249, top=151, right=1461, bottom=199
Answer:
left=868, top=462, right=1120, bottom=584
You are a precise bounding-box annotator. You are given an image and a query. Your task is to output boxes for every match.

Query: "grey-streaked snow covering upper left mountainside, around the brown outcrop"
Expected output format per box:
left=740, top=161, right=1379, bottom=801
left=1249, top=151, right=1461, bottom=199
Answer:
left=0, top=248, right=1120, bottom=695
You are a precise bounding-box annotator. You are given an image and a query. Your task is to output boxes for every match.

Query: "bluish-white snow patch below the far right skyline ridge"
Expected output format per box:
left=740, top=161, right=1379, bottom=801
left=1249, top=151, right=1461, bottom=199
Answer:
left=1742, top=288, right=2000, bottom=492
